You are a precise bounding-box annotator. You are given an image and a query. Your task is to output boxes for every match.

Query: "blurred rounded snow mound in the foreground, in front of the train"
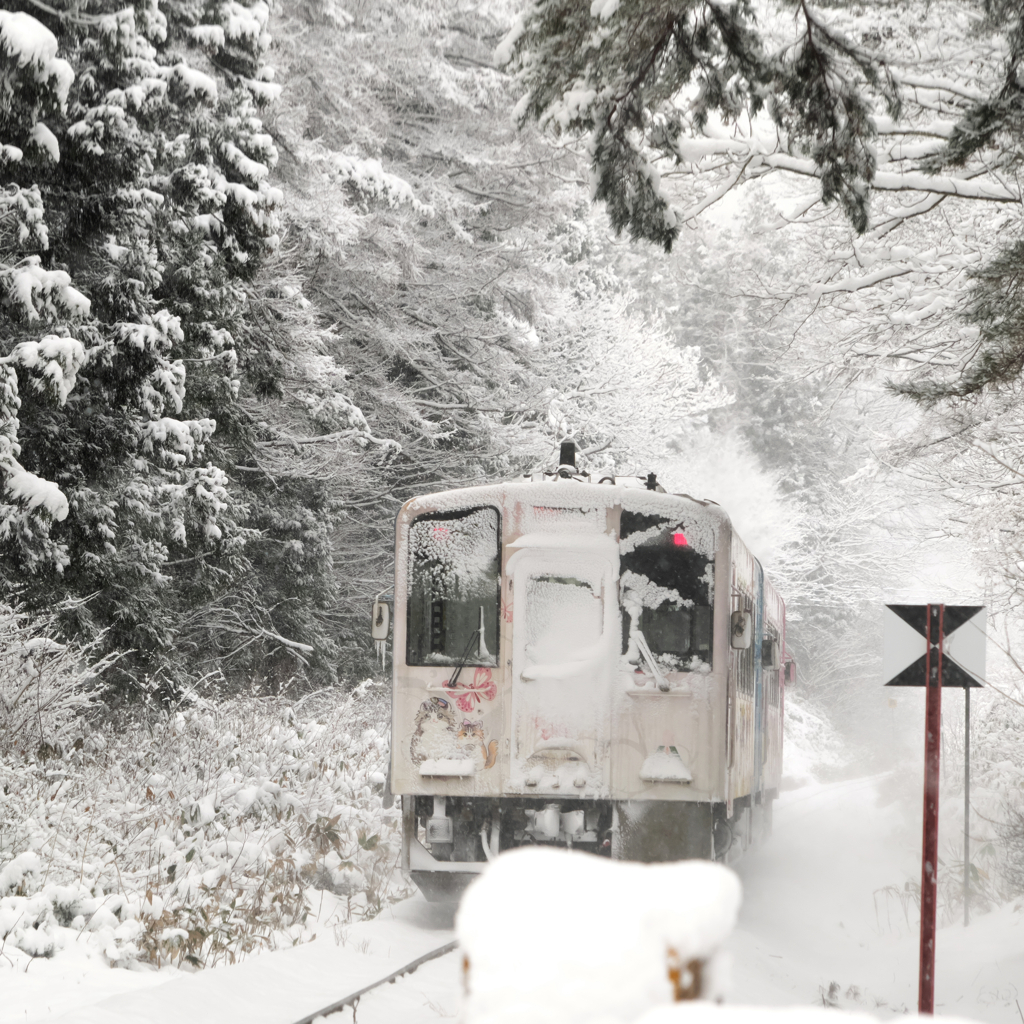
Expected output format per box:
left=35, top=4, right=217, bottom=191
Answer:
left=456, top=848, right=740, bottom=1024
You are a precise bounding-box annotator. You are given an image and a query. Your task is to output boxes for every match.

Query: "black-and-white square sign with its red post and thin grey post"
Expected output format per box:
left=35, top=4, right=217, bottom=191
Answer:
left=883, top=604, right=985, bottom=1014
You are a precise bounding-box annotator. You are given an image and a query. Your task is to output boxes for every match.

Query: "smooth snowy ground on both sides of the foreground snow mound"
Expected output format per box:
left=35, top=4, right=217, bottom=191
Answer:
left=0, top=772, right=1024, bottom=1024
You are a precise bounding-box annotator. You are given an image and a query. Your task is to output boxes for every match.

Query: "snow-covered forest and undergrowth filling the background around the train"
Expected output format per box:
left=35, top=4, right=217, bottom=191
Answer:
left=6, top=0, right=1024, bottom=1021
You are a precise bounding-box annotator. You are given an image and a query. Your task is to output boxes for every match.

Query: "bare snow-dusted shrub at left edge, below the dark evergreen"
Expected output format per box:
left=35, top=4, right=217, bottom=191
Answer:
left=0, top=604, right=105, bottom=761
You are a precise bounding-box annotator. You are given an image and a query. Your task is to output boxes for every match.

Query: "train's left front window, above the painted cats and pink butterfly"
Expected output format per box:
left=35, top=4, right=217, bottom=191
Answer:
left=406, top=508, right=501, bottom=666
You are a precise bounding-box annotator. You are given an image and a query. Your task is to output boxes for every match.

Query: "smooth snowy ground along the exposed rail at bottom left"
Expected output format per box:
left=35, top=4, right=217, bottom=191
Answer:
left=0, top=895, right=461, bottom=1024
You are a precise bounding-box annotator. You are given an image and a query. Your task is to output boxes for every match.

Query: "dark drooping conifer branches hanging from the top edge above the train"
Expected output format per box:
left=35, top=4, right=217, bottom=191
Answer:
left=497, top=0, right=898, bottom=249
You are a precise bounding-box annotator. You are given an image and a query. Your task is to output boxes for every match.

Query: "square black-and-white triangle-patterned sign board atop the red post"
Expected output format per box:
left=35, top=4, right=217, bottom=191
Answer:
left=882, top=604, right=985, bottom=687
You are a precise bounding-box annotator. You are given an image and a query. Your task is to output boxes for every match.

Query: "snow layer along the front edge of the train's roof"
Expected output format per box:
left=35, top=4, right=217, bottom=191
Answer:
left=403, top=477, right=729, bottom=556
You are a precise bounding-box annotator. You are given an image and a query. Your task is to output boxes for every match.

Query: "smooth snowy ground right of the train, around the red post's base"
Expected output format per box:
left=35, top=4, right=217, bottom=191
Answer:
left=730, top=774, right=1024, bottom=1024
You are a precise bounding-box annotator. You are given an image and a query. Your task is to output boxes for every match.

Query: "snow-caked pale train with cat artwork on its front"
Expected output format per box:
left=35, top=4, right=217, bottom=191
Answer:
left=373, top=442, right=790, bottom=900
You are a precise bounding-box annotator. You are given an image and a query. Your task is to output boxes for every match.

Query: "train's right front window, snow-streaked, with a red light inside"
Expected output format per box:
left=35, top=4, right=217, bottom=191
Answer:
left=620, top=509, right=714, bottom=670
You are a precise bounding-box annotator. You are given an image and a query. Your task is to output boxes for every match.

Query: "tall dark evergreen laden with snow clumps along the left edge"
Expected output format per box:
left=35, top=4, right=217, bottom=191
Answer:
left=0, top=0, right=292, bottom=696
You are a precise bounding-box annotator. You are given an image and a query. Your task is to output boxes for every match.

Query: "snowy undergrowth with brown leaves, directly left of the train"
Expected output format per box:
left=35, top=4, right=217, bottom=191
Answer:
left=0, top=683, right=404, bottom=967
